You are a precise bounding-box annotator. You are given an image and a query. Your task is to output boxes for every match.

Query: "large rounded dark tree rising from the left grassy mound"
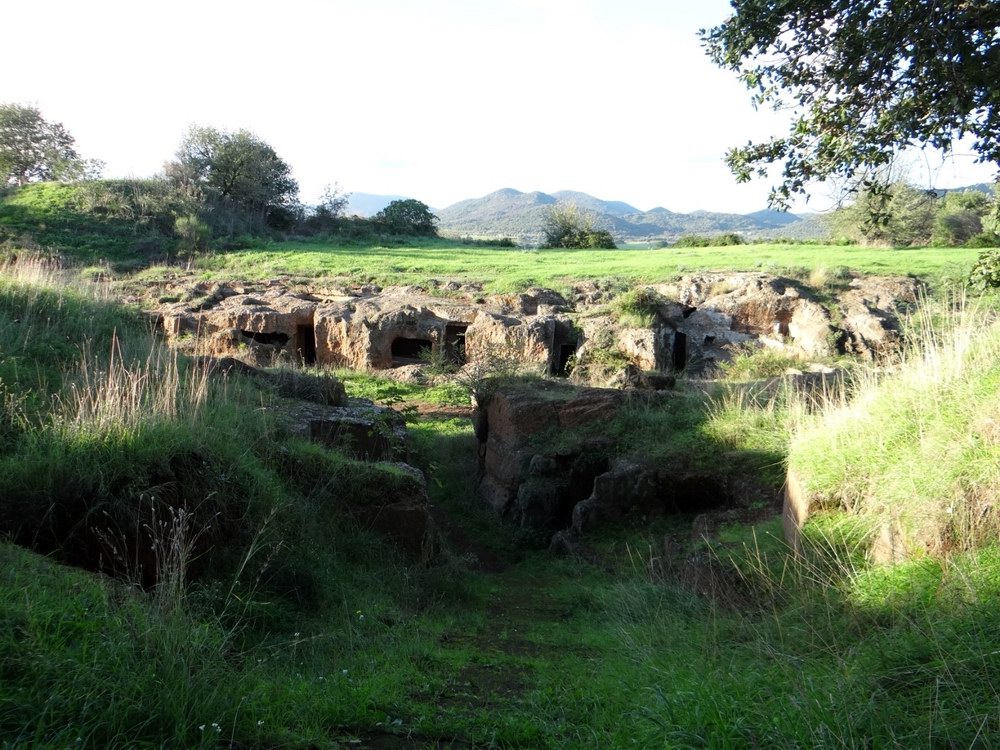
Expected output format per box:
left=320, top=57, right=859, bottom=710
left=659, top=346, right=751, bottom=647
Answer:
left=165, top=126, right=299, bottom=233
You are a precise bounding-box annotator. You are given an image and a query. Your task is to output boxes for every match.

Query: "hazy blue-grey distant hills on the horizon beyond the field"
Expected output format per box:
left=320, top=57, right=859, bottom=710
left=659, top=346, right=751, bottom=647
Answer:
left=437, top=188, right=827, bottom=245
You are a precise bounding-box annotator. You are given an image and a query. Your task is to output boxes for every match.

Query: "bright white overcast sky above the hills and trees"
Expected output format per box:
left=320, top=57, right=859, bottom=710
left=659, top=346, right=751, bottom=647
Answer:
left=0, top=0, right=993, bottom=213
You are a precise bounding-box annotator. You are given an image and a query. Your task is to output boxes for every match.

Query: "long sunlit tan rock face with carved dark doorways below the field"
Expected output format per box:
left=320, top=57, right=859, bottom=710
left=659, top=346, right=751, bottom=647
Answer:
left=157, top=272, right=919, bottom=387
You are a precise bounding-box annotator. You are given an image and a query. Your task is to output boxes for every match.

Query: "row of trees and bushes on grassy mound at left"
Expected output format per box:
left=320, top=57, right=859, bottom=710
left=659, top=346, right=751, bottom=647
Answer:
left=0, top=104, right=437, bottom=257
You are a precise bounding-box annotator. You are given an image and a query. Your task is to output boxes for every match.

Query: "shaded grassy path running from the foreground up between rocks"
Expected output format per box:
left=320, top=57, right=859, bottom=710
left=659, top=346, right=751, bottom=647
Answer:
left=378, top=415, right=644, bottom=748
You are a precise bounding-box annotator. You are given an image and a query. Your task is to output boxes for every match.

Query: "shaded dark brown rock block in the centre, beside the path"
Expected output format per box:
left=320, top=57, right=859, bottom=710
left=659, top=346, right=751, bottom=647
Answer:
left=476, top=384, right=731, bottom=535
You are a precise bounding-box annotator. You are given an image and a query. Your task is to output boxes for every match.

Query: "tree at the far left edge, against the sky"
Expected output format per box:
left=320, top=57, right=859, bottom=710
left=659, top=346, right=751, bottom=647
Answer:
left=0, top=104, right=97, bottom=185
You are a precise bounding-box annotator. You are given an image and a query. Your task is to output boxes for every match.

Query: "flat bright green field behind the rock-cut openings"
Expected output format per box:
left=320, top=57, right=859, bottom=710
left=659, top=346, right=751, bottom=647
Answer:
left=150, top=240, right=980, bottom=292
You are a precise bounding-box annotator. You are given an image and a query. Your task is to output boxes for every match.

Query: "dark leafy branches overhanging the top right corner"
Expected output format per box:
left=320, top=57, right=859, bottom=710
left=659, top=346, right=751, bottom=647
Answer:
left=701, top=0, right=1000, bottom=208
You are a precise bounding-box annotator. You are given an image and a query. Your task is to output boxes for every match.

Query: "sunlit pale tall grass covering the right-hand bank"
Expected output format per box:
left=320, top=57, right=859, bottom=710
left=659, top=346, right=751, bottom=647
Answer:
left=789, top=296, right=1000, bottom=556
